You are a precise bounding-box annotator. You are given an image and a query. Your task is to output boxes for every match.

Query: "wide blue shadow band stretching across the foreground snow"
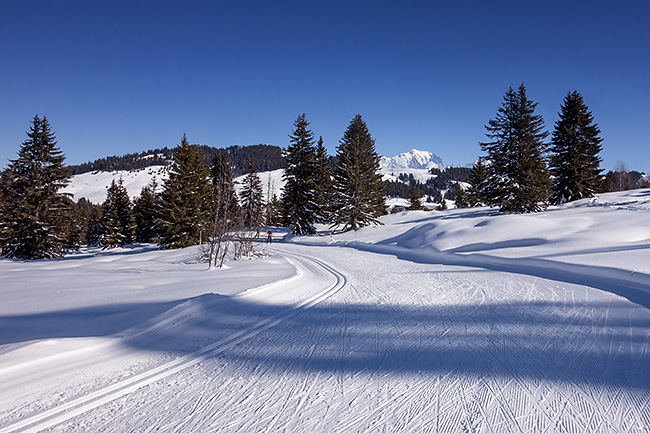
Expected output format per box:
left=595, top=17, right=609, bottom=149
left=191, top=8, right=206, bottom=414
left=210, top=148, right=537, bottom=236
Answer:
left=0, top=289, right=650, bottom=390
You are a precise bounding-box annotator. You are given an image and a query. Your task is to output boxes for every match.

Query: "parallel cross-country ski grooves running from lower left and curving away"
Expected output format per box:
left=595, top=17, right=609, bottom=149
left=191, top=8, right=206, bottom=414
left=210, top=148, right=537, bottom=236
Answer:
left=0, top=251, right=347, bottom=433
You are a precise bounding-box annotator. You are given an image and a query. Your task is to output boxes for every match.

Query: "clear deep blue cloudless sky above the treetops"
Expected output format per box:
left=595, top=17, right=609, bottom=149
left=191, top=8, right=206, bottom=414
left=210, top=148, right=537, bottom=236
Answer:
left=0, top=0, right=650, bottom=172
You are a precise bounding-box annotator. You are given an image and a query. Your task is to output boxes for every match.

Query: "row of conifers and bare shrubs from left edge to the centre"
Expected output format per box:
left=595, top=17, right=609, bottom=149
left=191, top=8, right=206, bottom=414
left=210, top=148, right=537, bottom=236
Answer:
left=0, top=114, right=385, bottom=258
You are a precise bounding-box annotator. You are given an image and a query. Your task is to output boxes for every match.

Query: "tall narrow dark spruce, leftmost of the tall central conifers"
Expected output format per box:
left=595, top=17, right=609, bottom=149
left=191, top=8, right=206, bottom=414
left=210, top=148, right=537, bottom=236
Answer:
left=281, top=113, right=318, bottom=235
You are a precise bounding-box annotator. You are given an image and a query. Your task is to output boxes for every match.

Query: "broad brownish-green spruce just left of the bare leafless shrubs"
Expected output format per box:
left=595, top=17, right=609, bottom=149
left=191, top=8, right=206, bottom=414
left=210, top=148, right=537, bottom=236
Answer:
left=157, top=134, right=212, bottom=249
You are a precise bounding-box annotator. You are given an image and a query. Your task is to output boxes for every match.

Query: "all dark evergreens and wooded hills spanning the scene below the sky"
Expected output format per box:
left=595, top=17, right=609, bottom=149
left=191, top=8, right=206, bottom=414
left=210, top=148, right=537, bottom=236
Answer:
left=0, top=83, right=650, bottom=258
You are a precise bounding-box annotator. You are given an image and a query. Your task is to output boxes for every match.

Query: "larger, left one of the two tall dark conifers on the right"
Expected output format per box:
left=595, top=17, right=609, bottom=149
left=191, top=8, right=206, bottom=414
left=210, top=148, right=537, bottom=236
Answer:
left=480, top=84, right=550, bottom=213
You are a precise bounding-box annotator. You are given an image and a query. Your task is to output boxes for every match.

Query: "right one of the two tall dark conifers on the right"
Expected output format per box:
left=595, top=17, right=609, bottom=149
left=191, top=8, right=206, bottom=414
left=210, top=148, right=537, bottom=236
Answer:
left=549, top=91, right=603, bottom=204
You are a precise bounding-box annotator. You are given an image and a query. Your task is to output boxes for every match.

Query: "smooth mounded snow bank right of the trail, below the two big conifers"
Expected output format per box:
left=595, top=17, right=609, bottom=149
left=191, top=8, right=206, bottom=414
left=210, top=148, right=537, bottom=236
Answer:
left=296, top=189, right=650, bottom=307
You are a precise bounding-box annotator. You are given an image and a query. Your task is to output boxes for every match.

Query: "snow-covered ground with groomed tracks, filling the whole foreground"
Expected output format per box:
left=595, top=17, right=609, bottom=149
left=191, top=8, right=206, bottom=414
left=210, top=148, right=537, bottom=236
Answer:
left=0, top=189, right=650, bottom=433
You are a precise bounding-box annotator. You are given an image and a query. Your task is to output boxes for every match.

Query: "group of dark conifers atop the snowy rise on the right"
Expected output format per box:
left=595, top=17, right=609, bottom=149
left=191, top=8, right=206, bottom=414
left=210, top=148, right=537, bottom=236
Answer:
left=456, top=84, right=646, bottom=212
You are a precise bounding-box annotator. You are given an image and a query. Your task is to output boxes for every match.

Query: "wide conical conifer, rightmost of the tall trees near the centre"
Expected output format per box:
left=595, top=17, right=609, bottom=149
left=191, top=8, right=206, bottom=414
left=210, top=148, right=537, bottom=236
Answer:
left=333, top=115, right=386, bottom=231
